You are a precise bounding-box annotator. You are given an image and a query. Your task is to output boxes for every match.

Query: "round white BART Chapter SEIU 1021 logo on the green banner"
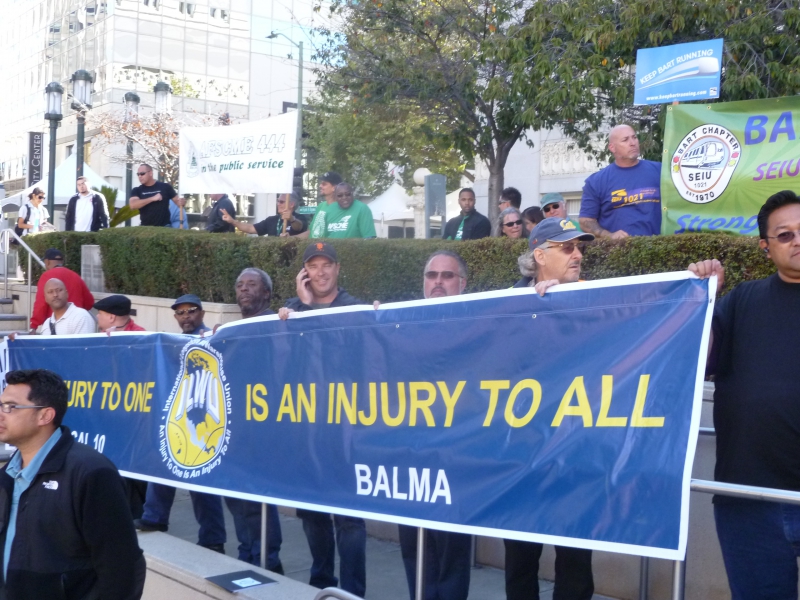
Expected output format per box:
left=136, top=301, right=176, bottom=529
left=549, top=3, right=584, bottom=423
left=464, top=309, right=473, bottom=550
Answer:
left=670, top=124, right=742, bottom=204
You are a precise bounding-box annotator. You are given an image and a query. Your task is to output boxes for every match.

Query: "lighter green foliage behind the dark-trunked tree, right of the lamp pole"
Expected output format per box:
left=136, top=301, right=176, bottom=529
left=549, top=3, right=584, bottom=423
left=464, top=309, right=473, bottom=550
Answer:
left=304, top=88, right=470, bottom=196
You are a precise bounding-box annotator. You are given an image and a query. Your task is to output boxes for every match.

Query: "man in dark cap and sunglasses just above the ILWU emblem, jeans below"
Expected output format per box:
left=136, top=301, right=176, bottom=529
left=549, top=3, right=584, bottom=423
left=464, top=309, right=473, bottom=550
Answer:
left=133, top=294, right=227, bottom=554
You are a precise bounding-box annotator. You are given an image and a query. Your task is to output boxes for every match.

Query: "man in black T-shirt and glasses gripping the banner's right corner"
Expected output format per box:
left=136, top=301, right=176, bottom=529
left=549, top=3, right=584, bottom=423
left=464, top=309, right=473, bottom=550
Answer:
left=704, top=191, right=800, bottom=600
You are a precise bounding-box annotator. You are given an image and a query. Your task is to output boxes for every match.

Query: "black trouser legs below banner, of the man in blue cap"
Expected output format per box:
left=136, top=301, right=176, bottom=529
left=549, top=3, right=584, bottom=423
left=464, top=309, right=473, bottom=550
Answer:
left=503, top=540, right=594, bottom=600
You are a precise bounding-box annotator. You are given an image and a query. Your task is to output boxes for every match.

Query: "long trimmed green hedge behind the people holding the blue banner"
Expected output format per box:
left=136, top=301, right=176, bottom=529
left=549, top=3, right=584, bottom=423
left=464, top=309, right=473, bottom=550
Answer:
left=21, top=227, right=774, bottom=309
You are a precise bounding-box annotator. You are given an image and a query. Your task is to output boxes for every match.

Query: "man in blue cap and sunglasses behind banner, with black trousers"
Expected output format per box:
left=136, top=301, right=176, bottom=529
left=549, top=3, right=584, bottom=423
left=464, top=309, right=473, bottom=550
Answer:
left=504, top=214, right=594, bottom=600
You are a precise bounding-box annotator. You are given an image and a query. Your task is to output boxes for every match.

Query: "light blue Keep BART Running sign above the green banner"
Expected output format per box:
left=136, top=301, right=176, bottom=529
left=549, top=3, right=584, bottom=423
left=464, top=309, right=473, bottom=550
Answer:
left=633, top=38, right=723, bottom=106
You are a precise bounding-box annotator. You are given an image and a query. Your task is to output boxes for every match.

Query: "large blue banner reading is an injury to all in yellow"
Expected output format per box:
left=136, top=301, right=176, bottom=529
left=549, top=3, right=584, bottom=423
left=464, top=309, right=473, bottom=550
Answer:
left=1, top=273, right=715, bottom=559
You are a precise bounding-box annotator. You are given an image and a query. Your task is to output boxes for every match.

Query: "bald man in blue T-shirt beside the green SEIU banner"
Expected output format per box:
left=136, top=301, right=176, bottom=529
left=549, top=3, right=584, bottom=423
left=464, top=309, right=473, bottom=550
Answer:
left=578, top=125, right=661, bottom=239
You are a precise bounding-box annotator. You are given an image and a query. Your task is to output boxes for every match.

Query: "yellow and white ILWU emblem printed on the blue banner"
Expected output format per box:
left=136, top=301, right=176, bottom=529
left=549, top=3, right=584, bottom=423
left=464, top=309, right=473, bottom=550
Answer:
left=159, top=340, right=231, bottom=479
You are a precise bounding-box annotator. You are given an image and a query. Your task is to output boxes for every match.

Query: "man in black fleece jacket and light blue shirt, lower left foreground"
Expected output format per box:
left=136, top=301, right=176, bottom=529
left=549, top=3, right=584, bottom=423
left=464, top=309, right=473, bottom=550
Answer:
left=0, top=369, right=145, bottom=600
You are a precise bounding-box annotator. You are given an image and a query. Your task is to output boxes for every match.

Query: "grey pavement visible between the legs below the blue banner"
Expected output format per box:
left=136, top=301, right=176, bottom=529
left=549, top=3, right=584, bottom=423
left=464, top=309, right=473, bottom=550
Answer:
left=168, top=490, right=612, bottom=600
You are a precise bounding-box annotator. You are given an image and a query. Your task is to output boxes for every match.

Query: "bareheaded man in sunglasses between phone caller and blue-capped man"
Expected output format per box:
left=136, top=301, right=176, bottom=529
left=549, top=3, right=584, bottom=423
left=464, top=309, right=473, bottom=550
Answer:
left=398, top=250, right=472, bottom=600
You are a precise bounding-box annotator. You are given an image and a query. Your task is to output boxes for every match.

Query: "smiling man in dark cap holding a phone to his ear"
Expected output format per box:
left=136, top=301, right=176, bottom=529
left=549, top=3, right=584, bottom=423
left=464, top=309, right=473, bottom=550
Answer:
left=278, top=242, right=367, bottom=598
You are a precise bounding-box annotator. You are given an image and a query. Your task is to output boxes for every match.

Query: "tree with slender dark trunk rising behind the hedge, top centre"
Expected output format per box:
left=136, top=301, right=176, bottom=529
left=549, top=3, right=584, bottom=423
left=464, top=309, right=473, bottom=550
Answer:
left=317, top=0, right=527, bottom=232
